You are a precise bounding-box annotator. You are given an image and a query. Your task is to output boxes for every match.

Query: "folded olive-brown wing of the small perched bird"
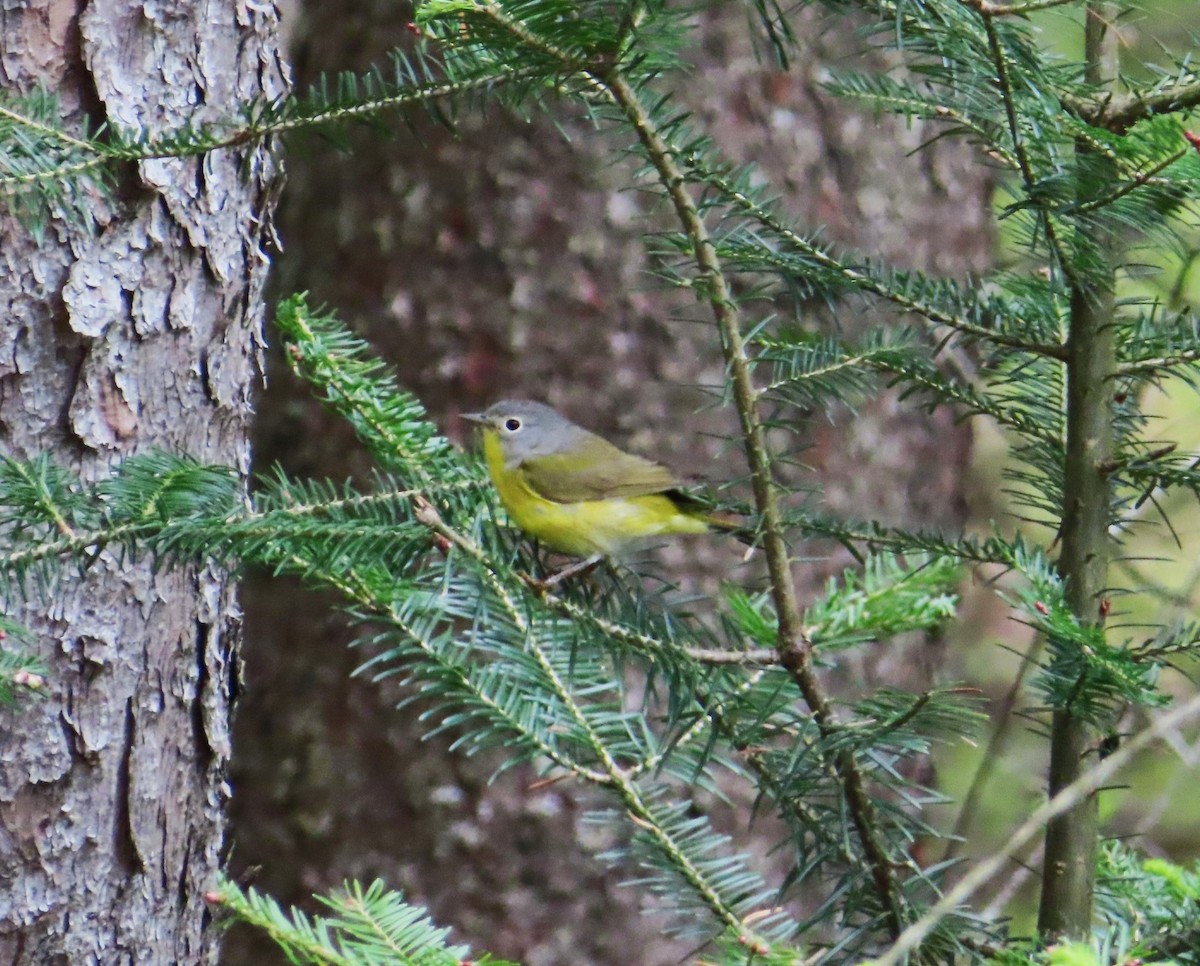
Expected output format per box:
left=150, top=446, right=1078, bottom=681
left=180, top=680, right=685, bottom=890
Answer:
left=521, top=436, right=678, bottom=503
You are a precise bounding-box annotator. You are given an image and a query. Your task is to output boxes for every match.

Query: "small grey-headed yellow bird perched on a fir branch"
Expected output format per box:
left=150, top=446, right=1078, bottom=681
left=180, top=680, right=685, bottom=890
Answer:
left=462, top=400, right=740, bottom=562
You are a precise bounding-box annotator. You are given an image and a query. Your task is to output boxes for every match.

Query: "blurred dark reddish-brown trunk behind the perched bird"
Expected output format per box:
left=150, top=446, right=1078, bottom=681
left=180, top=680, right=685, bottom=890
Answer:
left=224, top=0, right=991, bottom=966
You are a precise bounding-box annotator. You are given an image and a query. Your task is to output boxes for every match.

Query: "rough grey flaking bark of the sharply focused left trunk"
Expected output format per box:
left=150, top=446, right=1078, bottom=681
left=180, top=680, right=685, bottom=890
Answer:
left=0, top=0, right=283, bottom=966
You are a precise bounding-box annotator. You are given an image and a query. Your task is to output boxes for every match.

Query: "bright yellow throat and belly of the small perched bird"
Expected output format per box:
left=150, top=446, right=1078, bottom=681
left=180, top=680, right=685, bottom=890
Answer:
left=484, top=436, right=709, bottom=557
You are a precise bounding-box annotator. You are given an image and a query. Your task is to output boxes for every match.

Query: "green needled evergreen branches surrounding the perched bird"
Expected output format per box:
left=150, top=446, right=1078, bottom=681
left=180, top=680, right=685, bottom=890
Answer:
left=0, top=0, right=1200, bottom=964
